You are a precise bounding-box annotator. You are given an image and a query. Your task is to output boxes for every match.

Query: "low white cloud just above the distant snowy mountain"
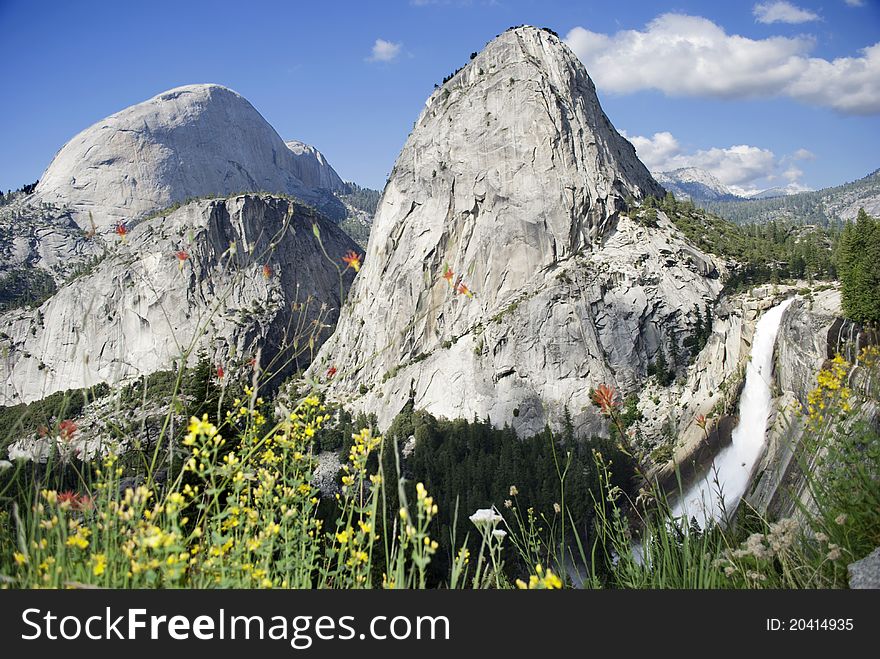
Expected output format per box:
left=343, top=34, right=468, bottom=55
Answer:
left=623, top=131, right=815, bottom=196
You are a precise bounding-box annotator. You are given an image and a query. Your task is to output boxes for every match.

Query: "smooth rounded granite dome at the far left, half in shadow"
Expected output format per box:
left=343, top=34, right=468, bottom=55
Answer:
left=35, top=85, right=338, bottom=230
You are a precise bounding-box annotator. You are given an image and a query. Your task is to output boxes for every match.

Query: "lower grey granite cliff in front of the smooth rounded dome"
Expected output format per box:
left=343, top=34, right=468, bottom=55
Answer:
left=0, top=195, right=356, bottom=405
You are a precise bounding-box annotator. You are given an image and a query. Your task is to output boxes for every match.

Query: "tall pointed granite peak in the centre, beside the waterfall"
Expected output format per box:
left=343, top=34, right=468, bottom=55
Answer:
left=316, top=27, right=721, bottom=432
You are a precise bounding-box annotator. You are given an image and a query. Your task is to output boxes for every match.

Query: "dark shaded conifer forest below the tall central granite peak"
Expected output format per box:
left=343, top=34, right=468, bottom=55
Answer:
left=374, top=404, right=635, bottom=575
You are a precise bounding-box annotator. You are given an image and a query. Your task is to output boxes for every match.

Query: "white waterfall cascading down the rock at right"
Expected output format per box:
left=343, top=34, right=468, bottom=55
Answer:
left=672, top=299, right=792, bottom=528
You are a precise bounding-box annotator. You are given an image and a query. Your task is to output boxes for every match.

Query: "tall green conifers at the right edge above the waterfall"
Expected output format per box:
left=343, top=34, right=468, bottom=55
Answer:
left=836, top=208, right=880, bottom=325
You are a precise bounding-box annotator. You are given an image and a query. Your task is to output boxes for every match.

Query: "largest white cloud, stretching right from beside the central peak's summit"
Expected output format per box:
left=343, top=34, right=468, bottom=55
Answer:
left=565, top=14, right=880, bottom=114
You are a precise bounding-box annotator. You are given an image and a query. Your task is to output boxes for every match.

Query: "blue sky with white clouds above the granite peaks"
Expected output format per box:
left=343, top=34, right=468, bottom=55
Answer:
left=0, top=0, right=880, bottom=191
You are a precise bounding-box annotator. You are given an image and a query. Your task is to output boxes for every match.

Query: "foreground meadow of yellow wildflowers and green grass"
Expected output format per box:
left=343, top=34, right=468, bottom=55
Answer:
left=0, top=348, right=880, bottom=588
